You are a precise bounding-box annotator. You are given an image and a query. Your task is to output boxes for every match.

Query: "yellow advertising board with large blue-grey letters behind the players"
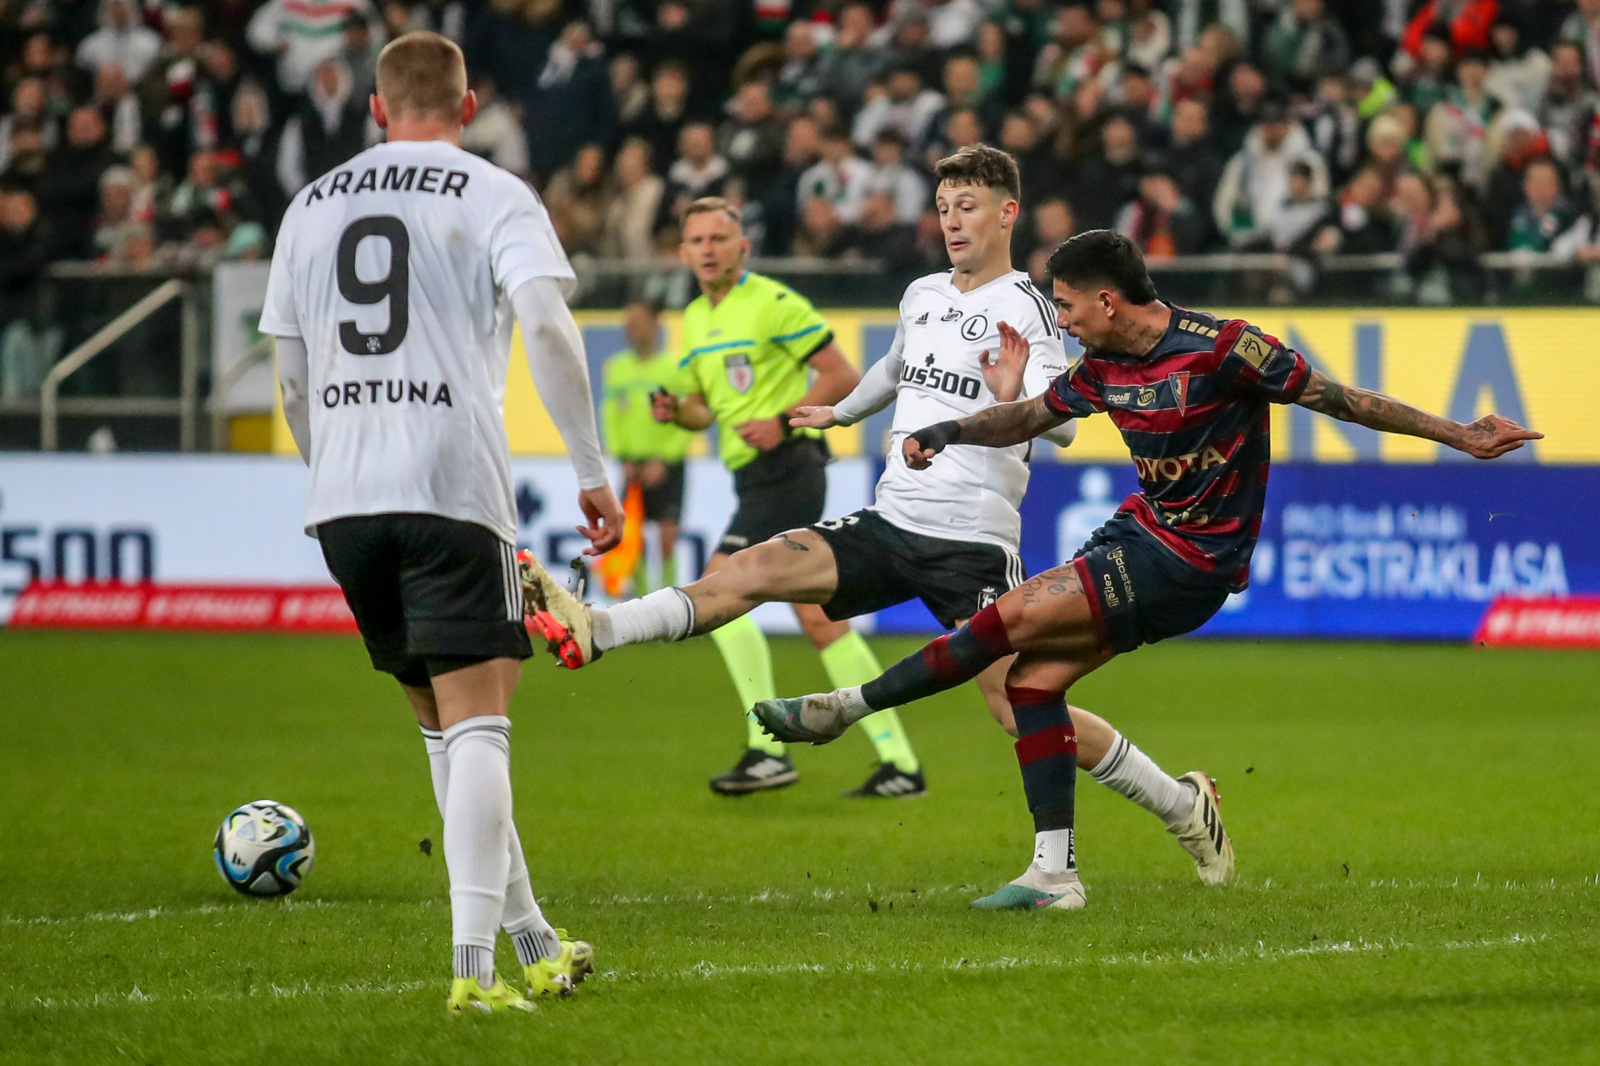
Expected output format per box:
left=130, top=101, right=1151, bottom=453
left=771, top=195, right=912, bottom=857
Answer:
left=274, top=307, right=1600, bottom=463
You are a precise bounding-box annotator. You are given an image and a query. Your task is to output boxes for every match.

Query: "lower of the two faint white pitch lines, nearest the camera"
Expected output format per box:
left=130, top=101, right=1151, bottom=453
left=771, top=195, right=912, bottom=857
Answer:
left=13, top=933, right=1549, bottom=1010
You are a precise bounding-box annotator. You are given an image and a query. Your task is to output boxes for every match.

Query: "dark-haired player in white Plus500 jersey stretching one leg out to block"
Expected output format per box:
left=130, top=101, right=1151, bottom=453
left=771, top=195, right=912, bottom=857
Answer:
left=530, top=146, right=1234, bottom=889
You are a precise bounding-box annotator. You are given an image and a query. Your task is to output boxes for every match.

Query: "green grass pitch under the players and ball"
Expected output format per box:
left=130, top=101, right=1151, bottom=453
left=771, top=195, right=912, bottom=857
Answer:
left=0, top=632, right=1600, bottom=1063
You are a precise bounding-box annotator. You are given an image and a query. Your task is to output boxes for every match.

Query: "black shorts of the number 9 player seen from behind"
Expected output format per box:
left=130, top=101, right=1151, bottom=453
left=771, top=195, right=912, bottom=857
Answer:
left=317, top=514, right=533, bottom=685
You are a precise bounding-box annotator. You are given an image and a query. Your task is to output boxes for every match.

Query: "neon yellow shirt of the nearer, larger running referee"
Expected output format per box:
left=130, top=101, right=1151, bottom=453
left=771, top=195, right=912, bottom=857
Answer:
left=678, top=271, right=834, bottom=471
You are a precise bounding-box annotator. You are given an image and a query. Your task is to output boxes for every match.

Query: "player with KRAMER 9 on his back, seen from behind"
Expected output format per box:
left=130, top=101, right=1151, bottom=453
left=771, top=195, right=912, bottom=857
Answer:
left=261, top=34, right=622, bottom=1012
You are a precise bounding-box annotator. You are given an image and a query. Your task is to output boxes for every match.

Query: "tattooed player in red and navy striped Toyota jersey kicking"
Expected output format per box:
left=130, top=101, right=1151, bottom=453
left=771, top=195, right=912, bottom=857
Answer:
left=754, top=229, right=1542, bottom=909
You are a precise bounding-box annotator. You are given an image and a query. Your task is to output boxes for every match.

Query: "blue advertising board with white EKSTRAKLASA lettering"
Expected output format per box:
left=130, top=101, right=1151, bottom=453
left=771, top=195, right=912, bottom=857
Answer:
left=877, top=463, right=1600, bottom=640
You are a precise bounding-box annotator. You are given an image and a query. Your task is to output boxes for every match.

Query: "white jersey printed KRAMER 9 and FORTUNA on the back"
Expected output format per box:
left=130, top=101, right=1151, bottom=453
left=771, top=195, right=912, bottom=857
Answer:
left=261, top=141, right=574, bottom=543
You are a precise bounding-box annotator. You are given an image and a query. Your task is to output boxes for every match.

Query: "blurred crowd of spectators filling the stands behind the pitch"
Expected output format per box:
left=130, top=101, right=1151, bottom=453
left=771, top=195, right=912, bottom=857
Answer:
left=9, top=0, right=1600, bottom=287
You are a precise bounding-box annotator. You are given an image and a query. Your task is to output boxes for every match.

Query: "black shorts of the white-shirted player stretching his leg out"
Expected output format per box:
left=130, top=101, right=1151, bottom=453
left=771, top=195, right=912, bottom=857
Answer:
left=811, top=511, right=1022, bottom=629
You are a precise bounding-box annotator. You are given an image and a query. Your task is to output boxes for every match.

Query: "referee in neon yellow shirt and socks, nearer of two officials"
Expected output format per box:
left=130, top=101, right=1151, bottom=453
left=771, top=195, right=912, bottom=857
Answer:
left=653, top=197, right=922, bottom=795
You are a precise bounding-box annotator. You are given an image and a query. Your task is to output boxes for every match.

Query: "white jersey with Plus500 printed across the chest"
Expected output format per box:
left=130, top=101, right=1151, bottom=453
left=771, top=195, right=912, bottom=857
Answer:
left=872, top=271, right=1067, bottom=552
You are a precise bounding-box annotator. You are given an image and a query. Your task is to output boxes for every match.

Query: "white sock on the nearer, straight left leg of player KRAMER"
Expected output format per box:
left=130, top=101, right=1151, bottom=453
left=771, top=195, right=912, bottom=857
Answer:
left=445, top=714, right=512, bottom=984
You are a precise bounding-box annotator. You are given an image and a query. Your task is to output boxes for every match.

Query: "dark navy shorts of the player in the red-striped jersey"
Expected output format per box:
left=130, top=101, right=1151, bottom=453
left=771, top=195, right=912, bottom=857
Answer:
left=1072, top=514, right=1229, bottom=653
